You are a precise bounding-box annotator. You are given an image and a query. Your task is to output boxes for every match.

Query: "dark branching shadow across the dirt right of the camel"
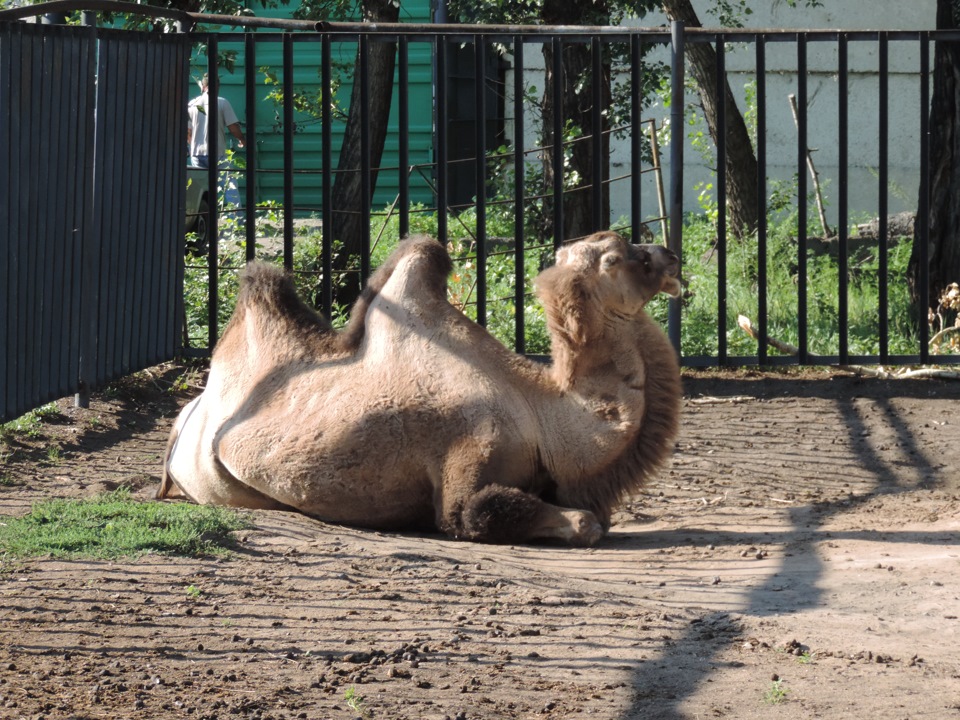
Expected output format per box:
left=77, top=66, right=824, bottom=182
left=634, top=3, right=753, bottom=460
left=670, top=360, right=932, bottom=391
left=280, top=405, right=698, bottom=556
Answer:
left=624, top=380, right=960, bottom=720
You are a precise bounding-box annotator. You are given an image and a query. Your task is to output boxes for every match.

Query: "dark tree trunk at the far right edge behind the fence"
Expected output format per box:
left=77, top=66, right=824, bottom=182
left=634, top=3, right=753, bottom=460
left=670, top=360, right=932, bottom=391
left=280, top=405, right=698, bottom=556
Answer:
left=909, top=0, right=960, bottom=322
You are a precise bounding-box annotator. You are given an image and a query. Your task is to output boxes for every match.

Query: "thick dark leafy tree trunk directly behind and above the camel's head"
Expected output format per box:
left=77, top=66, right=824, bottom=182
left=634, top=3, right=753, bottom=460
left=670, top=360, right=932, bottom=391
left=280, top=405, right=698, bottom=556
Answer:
left=543, top=0, right=611, bottom=242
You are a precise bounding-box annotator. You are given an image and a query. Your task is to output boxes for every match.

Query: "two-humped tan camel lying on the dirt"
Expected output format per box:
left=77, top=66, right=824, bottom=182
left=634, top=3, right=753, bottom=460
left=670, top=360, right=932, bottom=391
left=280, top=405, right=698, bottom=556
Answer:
left=158, top=232, right=681, bottom=545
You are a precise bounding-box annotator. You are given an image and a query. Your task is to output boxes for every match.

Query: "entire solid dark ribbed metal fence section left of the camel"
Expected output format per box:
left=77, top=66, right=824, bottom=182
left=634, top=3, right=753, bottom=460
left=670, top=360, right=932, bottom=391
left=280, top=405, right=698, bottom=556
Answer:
left=0, top=23, right=190, bottom=420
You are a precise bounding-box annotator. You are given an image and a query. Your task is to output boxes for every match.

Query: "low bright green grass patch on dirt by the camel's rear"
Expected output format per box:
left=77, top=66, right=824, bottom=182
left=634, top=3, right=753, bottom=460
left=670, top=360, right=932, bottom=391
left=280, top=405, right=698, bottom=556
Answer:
left=0, top=489, right=251, bottom=559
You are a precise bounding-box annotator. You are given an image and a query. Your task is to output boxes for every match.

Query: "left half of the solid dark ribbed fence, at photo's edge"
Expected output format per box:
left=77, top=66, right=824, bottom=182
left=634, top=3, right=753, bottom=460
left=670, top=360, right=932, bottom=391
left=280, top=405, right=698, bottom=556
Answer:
left=0, top=23, right=96, bottom=419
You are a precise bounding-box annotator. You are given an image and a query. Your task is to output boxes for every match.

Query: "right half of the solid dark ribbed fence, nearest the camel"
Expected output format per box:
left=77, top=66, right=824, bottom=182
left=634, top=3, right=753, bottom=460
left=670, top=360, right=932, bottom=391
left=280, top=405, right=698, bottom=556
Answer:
left=81, top=31, right=190, bottom=394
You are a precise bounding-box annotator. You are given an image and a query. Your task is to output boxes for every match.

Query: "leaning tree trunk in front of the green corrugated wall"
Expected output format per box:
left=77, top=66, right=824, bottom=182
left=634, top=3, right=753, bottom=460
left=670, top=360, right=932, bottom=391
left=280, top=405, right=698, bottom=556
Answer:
left=331, top=0, right=400, bottom=306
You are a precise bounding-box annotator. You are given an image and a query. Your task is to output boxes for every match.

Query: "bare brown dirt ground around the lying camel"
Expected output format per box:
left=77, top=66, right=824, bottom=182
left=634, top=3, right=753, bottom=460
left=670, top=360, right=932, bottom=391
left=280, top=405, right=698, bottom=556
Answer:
left=0, top=365, right=960, bottom=720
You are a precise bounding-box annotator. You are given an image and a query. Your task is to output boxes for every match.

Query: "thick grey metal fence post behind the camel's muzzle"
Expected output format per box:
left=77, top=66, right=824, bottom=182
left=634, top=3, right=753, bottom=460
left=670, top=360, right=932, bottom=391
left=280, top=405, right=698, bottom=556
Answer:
left=667, top=20, right=686, bottom=357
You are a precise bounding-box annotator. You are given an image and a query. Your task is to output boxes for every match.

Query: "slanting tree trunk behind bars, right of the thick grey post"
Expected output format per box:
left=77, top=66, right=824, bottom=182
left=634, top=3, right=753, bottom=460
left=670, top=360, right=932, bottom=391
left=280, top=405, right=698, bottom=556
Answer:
left=661, top=0, right=758, bottom=237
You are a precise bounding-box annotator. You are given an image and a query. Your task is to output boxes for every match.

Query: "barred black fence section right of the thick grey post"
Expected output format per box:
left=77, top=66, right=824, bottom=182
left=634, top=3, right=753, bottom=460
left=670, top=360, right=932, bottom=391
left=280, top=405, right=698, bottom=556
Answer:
left=670, top=27, right=960, bottom=366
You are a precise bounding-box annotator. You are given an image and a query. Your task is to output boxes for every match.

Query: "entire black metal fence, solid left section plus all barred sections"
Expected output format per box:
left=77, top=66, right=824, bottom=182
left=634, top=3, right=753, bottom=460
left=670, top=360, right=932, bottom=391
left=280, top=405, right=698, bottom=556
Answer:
left=0, top=7, right=960, bottom=418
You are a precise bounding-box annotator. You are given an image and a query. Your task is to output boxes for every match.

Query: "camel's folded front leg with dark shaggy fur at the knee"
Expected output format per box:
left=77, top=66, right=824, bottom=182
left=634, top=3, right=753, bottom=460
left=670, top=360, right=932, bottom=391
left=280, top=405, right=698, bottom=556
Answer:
left=461, top=485, right=604, bottom=547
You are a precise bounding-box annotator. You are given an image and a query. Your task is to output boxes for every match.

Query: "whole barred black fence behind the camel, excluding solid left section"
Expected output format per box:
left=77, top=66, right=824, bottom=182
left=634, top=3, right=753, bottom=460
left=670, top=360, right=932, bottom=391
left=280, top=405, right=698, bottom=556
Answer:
left=182, top=23, right=960, bottom=366
